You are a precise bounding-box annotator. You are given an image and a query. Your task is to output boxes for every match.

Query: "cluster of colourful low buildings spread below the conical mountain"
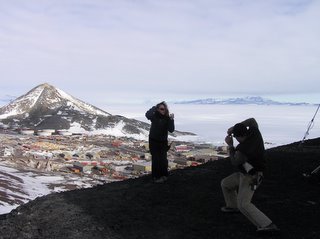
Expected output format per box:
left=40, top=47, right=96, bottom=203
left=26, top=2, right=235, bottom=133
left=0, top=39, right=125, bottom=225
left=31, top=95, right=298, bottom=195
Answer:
left=0, top=129, right=230, bottom=181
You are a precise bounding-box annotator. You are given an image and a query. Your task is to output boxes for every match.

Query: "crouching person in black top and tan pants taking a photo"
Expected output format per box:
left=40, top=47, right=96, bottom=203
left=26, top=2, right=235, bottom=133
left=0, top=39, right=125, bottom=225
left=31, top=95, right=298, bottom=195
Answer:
left=221, top=118, right=279, bottom=232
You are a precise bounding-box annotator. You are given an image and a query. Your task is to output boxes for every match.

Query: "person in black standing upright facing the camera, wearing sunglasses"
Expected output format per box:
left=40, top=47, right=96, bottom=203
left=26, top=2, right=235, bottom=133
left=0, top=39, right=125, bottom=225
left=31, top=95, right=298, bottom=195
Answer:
left=146, top=101, right=174, bottom=183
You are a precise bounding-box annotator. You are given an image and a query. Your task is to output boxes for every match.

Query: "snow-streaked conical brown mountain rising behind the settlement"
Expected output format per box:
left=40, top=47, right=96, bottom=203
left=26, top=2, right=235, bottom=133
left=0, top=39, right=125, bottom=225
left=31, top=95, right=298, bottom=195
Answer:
left=0, top=83, right=189, bottom=139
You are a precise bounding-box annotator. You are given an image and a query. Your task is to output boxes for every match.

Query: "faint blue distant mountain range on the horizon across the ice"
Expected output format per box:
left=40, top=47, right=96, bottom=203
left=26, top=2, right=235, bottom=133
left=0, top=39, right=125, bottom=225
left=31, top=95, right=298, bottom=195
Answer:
left=174, top=96, right=309, bottom=105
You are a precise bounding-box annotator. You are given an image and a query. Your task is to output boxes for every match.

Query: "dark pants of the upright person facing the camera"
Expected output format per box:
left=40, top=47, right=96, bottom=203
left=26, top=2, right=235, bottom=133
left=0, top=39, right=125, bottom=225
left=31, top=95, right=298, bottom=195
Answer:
left=149, top=139, right=168, bottom=178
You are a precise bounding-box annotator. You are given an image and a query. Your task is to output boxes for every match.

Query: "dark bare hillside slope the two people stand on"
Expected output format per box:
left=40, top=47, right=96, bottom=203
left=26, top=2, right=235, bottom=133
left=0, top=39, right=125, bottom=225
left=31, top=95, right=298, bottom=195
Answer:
left=0, top=139, right=320, bottom=239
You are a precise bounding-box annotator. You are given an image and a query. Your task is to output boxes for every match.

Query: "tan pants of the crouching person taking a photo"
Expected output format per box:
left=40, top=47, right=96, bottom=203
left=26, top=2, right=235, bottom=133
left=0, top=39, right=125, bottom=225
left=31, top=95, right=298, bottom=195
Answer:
left=221, top=172, right=272, bottom=227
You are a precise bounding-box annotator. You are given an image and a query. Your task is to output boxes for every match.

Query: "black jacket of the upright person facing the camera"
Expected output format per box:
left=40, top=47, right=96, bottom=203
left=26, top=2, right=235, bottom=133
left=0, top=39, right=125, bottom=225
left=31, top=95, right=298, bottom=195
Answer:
left=146, top=106, right=174, bottom=141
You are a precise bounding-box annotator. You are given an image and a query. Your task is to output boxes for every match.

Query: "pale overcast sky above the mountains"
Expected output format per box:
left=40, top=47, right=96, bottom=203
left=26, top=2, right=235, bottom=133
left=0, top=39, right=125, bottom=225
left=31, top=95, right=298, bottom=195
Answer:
left=0, top=0, right=320, bottom=106
